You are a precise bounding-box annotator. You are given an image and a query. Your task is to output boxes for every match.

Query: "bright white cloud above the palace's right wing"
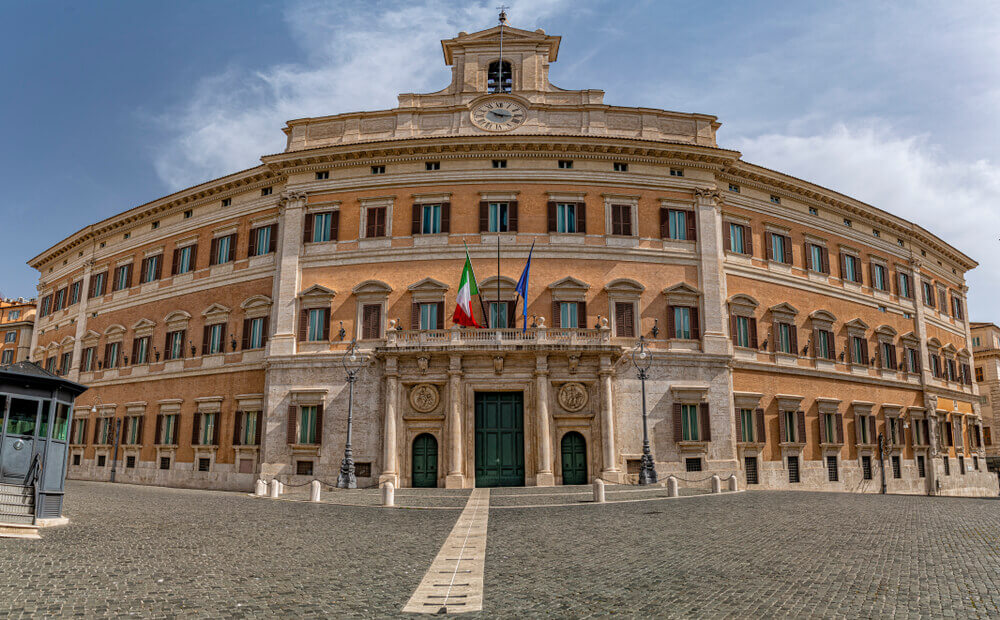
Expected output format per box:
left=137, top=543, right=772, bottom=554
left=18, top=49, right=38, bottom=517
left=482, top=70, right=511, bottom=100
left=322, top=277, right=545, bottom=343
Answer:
left=735, top=125, right=1000, bottom=321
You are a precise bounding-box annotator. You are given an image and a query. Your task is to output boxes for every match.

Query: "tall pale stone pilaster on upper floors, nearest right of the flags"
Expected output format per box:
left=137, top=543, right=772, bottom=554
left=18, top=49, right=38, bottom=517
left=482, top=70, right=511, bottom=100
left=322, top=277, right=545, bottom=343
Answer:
left=695, top=187, right=733, bottom=355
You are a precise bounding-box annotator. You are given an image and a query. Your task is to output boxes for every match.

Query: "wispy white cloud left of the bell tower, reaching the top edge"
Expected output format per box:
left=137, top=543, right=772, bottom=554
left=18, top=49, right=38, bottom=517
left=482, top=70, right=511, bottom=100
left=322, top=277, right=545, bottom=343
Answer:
left=149, top=0, right=569, bottom=190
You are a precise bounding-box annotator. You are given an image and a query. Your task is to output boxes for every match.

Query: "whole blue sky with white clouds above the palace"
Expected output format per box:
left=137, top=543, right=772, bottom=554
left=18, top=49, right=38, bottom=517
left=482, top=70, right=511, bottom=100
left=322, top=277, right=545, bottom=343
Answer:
left=0, top=0, right=1000, bottom=314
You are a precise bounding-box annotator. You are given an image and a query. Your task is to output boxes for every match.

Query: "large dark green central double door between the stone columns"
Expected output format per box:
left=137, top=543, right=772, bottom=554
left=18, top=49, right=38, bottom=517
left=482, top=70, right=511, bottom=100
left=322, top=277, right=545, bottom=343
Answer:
left=476, top=392, right=524, bottom=487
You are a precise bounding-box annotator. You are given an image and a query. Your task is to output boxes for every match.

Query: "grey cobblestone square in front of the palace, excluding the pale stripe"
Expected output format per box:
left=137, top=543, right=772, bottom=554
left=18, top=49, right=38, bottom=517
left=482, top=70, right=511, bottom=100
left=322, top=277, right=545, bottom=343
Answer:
left=0, top=481, right=1000, bottom=618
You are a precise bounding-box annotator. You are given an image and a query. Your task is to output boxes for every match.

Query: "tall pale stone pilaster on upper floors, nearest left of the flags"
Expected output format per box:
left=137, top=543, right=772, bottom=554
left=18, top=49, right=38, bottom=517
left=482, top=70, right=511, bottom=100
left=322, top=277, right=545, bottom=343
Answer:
left=268, top=191, right=307, bottom=357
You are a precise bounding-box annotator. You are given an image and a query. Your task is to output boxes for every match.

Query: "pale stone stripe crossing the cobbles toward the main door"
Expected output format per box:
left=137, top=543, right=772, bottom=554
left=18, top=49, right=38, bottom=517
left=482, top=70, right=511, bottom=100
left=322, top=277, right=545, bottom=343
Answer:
left=403, top=489, right=490, bottom=614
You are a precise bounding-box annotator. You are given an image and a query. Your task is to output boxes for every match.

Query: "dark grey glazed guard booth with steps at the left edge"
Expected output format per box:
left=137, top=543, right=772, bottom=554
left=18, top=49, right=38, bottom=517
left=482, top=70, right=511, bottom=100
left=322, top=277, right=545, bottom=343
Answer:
left=0, top=362, right=87, bottom=525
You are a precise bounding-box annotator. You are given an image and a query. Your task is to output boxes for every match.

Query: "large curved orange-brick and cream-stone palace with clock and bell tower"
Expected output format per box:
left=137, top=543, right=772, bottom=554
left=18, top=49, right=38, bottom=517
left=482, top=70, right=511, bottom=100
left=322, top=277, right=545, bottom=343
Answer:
left=29, top=26, right=997, bottom=495
